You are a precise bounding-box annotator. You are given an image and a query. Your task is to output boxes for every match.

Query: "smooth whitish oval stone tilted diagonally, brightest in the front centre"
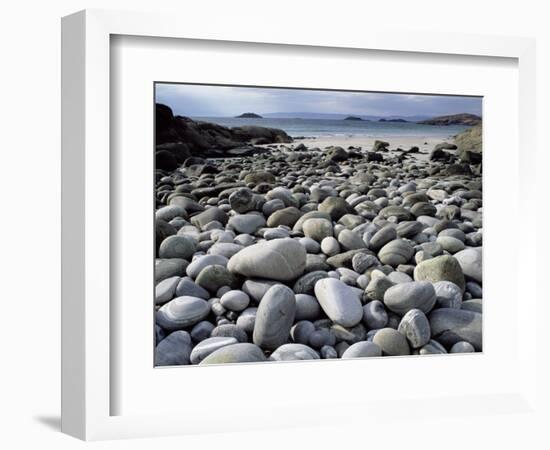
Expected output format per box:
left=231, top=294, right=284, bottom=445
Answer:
left=315, top=278, right=363, bottom=327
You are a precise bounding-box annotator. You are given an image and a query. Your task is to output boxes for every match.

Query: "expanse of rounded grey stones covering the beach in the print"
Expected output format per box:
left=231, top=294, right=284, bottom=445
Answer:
left=155, top=138, right=482, bottom=365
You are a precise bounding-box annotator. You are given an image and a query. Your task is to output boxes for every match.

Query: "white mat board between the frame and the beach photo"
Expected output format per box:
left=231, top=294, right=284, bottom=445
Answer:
left=111, top=37, right=520, bottom=418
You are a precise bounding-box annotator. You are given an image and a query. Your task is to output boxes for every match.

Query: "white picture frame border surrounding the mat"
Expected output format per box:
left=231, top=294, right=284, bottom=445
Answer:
left=62, top=10, right=537, bottom=440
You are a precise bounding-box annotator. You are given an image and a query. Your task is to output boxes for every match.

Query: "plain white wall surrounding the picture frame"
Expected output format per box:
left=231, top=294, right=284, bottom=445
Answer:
left=0, top=0, right=550, bottom=450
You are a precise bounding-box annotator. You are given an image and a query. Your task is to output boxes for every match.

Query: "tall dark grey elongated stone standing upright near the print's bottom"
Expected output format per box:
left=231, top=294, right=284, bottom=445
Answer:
left=253, top=284, right=296, bottom=350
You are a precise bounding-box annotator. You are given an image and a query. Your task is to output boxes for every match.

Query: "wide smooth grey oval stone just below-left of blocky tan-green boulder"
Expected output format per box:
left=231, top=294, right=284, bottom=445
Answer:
left=384, top=281, right=436, bottom=315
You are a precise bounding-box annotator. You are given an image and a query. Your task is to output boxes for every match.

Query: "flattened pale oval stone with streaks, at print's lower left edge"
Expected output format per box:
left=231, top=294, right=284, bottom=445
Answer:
left=156, top=297, right=210, bottom=330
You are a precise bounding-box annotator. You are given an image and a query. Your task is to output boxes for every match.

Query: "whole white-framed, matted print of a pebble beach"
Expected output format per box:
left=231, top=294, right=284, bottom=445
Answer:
left=62, top=11, right=536, bottom=439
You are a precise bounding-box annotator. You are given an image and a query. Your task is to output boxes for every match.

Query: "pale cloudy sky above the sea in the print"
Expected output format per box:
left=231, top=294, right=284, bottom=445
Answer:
left=156, top=84, right=481, bottom=117
